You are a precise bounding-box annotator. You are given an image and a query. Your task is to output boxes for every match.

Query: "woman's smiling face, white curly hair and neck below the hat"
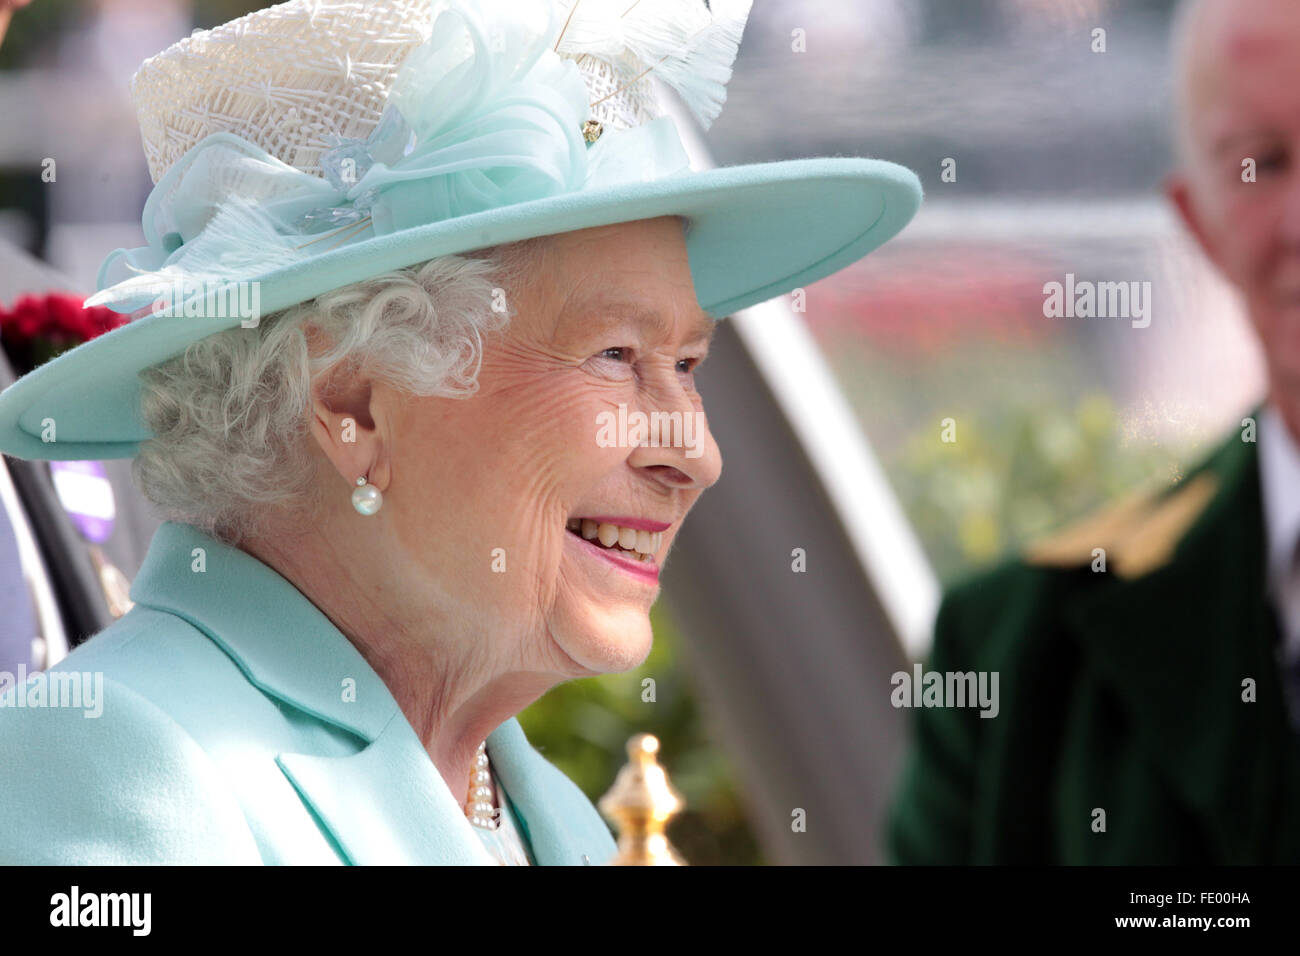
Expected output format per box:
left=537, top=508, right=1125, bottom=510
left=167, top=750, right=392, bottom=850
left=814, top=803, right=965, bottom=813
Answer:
left=120, top=216, right=720, bottom=858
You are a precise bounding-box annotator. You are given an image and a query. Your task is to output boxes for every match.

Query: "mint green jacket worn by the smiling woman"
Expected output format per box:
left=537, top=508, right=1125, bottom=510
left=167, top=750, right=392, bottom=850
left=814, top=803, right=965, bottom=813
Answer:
left=0, top=523, right=615, bottom=865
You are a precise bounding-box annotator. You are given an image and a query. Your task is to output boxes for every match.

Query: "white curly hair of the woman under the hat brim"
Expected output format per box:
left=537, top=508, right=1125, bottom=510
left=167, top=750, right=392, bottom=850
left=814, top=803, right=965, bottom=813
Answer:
left=133, top=237, right=547, bottom=545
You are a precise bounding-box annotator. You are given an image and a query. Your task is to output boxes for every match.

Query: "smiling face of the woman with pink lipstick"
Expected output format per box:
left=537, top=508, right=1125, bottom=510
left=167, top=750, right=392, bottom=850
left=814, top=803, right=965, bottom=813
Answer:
left=384, top=217, right=722, bottom=676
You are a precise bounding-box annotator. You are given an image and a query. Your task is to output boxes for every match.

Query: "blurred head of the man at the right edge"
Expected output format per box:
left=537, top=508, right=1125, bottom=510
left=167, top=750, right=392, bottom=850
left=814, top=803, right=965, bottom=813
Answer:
left=1167, top=0, right=1300, bottom=436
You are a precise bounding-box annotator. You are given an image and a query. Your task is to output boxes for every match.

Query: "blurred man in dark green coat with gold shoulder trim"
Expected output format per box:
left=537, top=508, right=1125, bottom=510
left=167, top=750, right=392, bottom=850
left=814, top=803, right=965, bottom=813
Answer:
left=888, top=0, right=1300, bottom=864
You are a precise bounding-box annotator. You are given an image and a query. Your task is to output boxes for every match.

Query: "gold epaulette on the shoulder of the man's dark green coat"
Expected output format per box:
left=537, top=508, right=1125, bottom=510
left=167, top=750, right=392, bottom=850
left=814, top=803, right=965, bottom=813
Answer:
left=1023, top=472, right=1218, bottom=579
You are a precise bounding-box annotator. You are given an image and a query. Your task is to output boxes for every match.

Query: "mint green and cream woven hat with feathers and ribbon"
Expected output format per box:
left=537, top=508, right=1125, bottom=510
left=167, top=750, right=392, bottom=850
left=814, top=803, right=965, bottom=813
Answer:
left=0, top=0, right=920, bottom=459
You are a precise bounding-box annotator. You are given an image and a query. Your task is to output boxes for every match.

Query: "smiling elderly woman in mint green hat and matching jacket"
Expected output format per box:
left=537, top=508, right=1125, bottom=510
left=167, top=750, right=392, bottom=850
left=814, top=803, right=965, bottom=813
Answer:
left=0, top=0, right=919, bottom=865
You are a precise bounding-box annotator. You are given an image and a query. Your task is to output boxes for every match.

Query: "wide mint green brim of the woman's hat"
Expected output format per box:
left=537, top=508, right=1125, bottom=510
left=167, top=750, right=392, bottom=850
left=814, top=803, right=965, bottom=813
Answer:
left=0, top=157, right=922, bottom=459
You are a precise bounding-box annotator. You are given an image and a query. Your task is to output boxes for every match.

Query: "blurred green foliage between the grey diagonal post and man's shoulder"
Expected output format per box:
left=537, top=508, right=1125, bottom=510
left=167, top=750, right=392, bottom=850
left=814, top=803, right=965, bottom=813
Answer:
left=822, top=336, right=1195, bottom=583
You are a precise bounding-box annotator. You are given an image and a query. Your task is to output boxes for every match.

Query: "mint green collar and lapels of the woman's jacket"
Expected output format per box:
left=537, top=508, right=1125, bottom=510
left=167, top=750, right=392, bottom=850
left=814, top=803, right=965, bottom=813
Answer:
left=131, top=522, right=608, bottom=865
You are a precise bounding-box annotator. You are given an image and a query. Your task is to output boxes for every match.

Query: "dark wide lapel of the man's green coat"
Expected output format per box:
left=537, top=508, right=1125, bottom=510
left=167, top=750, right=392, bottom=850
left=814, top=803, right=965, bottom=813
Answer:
left=1065, top=436, right=1294, bottom=862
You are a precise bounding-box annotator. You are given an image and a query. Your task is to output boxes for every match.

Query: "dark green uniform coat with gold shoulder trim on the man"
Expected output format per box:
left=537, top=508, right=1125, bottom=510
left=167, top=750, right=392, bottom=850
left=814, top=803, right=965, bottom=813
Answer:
left=887, top=434, right=1300, bottom=864
